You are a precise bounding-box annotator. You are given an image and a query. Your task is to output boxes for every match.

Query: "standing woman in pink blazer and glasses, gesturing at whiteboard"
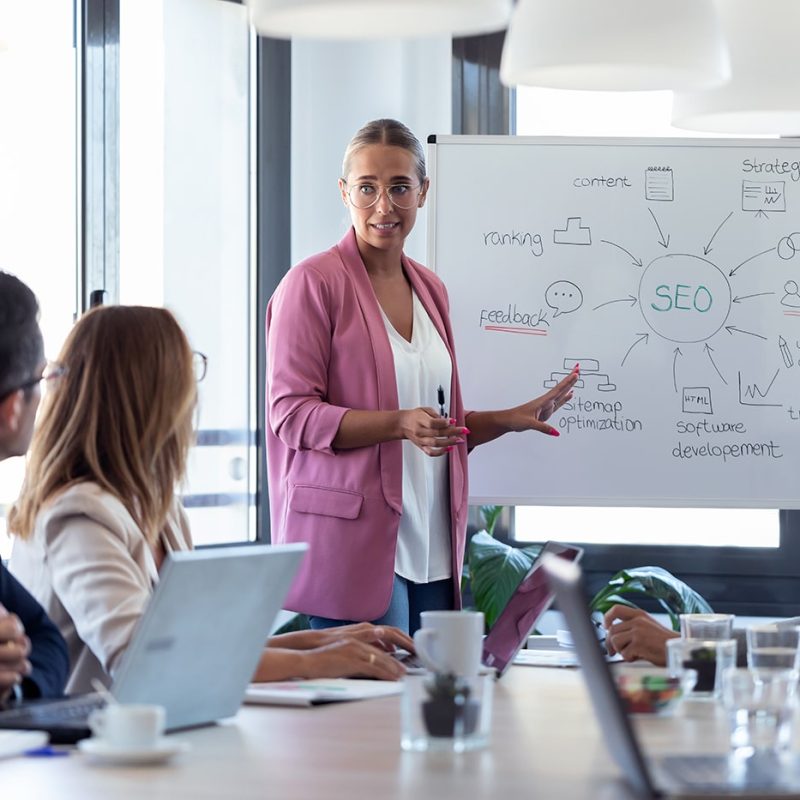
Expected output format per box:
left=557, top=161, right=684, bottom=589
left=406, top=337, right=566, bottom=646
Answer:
left=266, top=119, right=578, bottom=632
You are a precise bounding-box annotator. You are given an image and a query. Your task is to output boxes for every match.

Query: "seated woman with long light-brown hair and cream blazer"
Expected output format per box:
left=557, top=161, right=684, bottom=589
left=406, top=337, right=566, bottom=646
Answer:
left=9, top=306, right=412, bottom=692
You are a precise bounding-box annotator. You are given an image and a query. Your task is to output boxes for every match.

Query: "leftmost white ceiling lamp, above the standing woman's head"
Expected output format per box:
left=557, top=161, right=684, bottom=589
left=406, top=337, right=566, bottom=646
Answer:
left=248, top=0, right=512, bottom=39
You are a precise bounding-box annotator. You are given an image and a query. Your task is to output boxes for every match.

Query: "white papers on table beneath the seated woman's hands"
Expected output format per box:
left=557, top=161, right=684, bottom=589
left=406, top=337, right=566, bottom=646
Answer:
left=244, top=678, right=403, bottom=706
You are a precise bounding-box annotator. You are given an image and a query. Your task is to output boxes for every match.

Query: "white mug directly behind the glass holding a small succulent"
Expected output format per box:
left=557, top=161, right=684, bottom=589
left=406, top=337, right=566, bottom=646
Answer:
left=414, top=611, right=484, bottom=678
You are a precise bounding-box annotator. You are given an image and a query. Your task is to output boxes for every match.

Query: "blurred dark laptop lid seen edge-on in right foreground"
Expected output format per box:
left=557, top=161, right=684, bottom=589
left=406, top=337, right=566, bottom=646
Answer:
left=542, top=555, right=658, bottom=797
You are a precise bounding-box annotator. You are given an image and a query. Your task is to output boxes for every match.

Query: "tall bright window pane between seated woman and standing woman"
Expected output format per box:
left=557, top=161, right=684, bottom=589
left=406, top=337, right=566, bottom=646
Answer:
left=119, top=0, right=259, bottom=544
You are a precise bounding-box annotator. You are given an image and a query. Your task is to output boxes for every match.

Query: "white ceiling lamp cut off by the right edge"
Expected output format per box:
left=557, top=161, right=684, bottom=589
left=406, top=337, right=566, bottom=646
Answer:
left=672, top=0, right=800, bottom=136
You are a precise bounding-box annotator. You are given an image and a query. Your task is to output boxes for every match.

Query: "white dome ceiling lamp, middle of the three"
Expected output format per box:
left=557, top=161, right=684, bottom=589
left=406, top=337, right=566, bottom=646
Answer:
left=500, top=0, right=732, bottom=91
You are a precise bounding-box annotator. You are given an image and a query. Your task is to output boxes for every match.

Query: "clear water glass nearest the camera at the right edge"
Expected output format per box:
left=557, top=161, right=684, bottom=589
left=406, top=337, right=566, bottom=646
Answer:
left=722, top=668, right=798, bottom=758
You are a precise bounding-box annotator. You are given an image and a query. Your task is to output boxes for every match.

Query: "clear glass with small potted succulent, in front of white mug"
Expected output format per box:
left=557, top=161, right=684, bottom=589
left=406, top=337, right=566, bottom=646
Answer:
left=401, top=672, right=495, bottom=753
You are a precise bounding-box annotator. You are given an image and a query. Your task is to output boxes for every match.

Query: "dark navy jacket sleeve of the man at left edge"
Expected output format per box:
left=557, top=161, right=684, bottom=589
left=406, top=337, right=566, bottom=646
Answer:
left=0, top=564, right=69, bottom=697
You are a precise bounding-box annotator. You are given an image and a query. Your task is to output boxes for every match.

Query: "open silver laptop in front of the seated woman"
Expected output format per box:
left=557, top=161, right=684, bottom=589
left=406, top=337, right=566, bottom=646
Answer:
left=0, top=544, right=307, bottom=743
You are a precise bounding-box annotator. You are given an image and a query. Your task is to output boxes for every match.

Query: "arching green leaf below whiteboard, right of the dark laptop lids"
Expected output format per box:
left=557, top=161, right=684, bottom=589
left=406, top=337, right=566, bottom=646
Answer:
left=589, top=567, right=713, bottom=631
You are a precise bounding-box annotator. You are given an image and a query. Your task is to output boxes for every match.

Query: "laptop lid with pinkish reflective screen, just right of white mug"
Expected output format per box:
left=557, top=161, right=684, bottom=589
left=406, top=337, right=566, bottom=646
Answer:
left=483, top=542, right=583, bottom=677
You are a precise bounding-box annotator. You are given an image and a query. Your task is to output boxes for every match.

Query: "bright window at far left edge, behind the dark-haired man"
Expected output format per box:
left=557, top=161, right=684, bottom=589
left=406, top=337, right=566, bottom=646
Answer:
left=0, top=0, right=77, bottom=558
